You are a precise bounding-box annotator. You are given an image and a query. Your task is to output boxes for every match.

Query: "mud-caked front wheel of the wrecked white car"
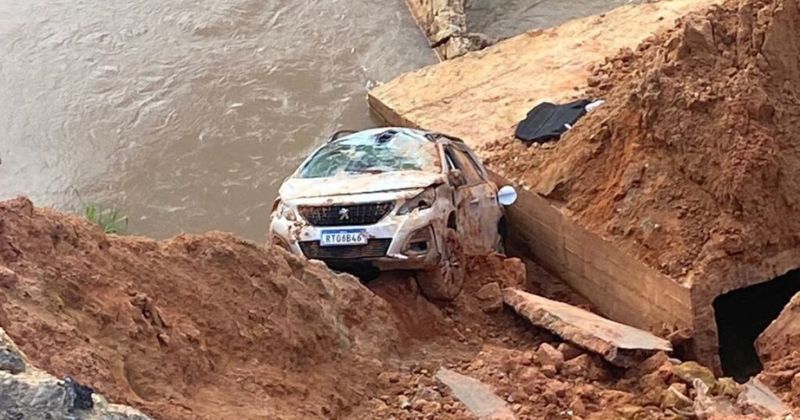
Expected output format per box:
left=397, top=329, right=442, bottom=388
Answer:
left=417, top=228, right=466, bottom=300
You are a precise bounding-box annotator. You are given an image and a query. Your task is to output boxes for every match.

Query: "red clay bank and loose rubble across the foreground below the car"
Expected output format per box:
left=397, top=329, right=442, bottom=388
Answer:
left=0, top=198, right=780, bottom=419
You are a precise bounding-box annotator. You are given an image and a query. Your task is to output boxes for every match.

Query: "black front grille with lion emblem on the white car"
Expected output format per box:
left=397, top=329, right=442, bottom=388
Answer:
left=298, top=201, right=394, bottom=226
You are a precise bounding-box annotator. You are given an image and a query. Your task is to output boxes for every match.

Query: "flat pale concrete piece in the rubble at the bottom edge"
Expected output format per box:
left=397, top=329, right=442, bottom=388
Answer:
left=436, top=368, right=516, bottom=420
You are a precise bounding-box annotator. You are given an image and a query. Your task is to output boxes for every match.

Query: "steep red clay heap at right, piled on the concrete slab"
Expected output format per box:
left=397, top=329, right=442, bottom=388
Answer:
left=483, top=0, right=800, bottom=284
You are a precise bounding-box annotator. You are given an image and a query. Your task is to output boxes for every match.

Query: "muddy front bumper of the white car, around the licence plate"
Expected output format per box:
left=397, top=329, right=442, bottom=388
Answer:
left=270, top=208, right=445, bottom=270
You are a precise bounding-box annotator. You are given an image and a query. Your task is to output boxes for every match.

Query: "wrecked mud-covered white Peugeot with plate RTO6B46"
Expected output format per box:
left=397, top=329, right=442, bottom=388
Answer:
left=270, top=128, right=517, bottom=300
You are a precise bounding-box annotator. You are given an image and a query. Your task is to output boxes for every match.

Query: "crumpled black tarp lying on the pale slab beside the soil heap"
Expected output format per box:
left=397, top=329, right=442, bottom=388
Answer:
left=514, top=100, right=592, bottom=143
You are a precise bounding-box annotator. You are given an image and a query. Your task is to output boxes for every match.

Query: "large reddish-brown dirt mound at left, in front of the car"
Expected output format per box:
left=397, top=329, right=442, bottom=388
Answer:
left=0, top=199, right=397, bottom=419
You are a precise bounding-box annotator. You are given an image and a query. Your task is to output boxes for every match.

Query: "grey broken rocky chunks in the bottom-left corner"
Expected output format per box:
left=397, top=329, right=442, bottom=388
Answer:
left=0, top=329, right=149, bottom=420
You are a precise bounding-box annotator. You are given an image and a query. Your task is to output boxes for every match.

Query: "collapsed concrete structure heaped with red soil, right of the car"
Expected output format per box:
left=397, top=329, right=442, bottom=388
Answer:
left=370, top=0, right=800, bottom=372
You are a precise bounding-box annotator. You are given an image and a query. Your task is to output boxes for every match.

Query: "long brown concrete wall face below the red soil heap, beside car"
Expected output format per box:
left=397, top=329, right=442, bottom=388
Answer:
left=495, top=171, right=693, bottom=333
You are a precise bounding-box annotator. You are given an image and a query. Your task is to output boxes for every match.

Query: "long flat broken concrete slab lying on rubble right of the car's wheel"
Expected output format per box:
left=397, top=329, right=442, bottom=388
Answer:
left=503, top=288, right=672, bottom=367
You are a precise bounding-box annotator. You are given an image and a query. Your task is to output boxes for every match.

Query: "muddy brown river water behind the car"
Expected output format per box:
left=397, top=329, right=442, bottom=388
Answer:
left=0, top=0, right=636, bottom=240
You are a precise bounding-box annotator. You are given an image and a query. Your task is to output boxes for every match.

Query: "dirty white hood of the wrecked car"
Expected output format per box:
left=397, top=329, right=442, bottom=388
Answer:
left=280, top=171, right=446, bottom=200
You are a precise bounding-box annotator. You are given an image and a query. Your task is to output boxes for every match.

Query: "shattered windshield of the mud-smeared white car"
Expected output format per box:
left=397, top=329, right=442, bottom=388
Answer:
left=300, top=131, right=440, bottom=178
